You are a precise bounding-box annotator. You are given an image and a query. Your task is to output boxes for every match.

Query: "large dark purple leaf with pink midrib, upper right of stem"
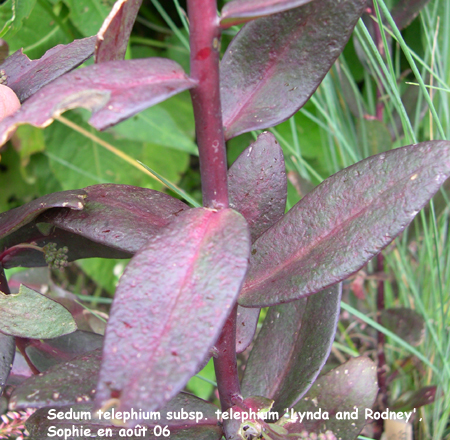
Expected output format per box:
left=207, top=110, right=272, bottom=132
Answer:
left=220, top=0, right=366, bottom=139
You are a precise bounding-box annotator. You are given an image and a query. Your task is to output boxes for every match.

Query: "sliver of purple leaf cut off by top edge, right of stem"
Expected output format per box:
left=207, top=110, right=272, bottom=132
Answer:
left=220, top=0, right=311, bottom=29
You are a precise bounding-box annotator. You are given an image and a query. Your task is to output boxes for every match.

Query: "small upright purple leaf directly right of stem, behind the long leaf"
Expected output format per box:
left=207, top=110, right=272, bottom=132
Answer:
left=228, top=132, right=287, bottom=242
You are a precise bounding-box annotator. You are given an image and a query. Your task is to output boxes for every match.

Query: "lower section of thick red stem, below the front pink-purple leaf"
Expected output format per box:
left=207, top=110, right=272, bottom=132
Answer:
left=214, top=304, right=242, bottom=411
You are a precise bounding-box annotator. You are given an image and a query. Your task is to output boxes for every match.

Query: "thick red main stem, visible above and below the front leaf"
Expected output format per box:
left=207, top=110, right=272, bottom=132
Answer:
left=187, top=0, right=242, bottom=411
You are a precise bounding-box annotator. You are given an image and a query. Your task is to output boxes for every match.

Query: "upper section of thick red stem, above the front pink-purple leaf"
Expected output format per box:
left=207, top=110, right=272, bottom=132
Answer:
left=187, top=0, right=228, bottom=209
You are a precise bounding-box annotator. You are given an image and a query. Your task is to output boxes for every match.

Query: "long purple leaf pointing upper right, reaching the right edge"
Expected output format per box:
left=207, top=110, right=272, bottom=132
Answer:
left=239, top=141, right=450, bottom=307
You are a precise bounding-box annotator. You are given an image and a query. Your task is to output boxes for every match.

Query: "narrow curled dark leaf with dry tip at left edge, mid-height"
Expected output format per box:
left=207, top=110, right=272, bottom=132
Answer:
left=0, top=189, right=86, bottom=239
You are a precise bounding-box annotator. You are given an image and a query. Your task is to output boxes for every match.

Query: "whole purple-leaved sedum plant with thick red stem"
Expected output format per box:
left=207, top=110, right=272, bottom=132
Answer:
left=0, top=0, right=450, bottom=440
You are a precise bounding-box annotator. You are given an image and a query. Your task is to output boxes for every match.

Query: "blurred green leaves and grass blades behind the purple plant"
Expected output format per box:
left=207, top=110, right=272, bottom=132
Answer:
left=0, top=0, right=450, bottom=440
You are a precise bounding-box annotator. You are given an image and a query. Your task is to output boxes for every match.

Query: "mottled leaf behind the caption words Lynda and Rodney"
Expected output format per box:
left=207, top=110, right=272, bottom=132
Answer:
left=284, top=357, right=378, bottom=440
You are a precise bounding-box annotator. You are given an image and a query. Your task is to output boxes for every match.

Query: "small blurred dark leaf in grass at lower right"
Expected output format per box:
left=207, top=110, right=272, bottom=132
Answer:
left=380, top=307, right=425, bottom=346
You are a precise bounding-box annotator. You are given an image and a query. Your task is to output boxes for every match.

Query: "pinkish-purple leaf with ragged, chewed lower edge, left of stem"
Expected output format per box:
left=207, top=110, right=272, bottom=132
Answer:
left=0, top=58, right=196, bottom=145
